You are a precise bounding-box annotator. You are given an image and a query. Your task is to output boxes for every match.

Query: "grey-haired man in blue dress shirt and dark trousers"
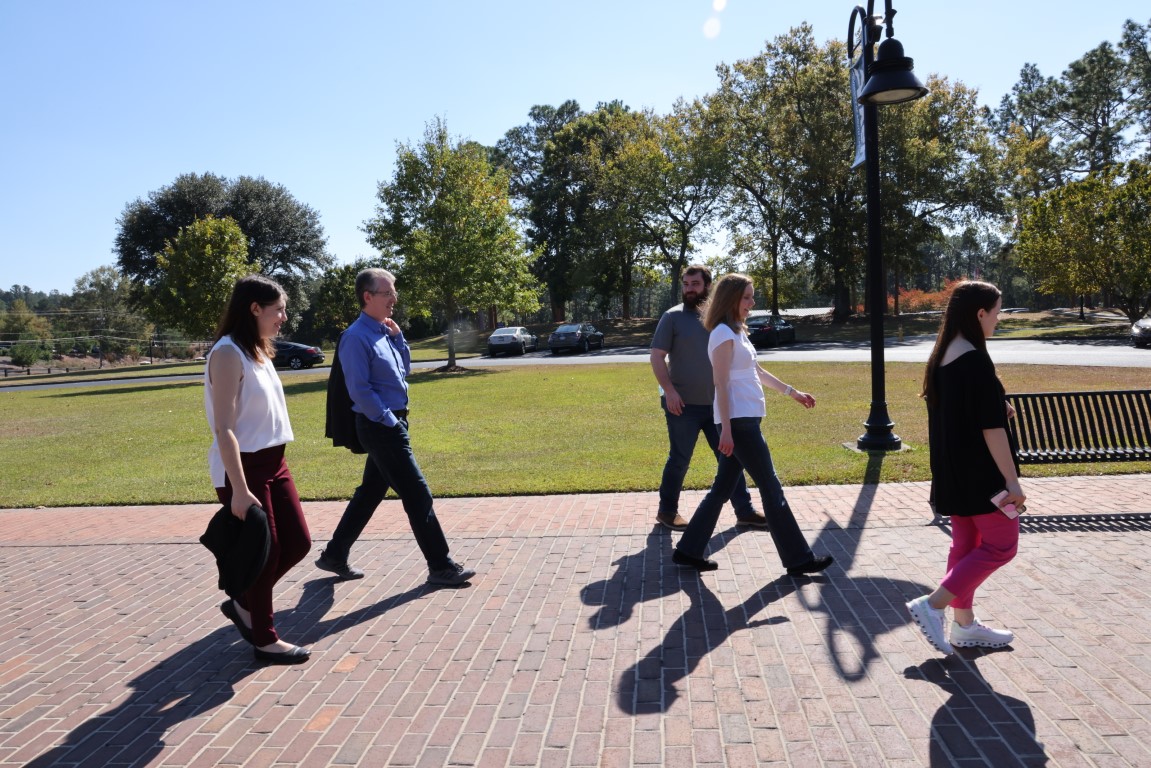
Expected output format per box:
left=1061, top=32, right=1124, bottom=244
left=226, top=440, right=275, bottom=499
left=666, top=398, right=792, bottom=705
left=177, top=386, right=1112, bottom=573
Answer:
left=315, top=268, right=475, bottom=586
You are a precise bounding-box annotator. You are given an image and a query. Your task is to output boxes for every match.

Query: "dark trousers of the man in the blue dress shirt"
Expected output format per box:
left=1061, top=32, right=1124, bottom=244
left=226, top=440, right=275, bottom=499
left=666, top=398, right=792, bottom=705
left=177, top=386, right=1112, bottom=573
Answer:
left=325, top=413, right=451, bottom=570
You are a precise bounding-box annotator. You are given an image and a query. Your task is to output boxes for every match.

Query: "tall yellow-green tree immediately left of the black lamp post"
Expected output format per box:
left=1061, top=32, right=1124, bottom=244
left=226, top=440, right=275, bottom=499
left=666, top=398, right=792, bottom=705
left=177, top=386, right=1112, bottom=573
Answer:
left=714, top=24, right=864, bottom=322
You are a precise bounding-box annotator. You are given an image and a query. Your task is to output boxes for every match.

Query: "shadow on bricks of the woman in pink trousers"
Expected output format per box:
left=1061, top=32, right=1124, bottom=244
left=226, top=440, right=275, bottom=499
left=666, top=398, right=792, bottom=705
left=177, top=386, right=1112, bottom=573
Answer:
left=904, top=649, right=1047, bottom=768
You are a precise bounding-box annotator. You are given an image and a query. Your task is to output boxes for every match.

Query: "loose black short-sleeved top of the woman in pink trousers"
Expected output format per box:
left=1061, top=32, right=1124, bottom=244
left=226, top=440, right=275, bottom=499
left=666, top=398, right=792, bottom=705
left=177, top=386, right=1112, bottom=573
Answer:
left=928, top=349, right=1019, bottom=517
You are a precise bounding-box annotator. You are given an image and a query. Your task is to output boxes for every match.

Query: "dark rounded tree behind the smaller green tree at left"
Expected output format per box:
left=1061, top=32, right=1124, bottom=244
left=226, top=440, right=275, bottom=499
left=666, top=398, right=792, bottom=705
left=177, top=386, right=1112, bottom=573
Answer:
left=114, top=174, right=333, bottom=325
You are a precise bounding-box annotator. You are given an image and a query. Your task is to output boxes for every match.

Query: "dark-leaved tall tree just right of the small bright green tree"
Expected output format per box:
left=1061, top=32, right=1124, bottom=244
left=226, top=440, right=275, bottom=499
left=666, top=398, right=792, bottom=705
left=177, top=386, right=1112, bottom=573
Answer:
left=495, top=100, right=586, bottom=322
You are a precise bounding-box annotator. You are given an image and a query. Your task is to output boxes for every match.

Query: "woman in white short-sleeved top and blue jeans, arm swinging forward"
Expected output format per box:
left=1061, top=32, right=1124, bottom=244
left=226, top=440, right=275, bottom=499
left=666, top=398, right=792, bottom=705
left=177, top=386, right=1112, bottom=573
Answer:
left=672, top=274, right=832, bottom=576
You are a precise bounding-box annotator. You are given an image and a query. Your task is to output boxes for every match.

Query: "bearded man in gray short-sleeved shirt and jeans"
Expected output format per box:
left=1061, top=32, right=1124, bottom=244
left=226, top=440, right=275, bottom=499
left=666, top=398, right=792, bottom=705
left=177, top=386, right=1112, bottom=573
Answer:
left=651, top=264, right=768, bottom=531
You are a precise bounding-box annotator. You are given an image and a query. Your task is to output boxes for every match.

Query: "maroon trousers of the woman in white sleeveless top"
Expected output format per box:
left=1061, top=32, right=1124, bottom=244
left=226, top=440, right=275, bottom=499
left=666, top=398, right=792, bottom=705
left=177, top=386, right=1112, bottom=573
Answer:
left=216, top=446, right=312, bottom=646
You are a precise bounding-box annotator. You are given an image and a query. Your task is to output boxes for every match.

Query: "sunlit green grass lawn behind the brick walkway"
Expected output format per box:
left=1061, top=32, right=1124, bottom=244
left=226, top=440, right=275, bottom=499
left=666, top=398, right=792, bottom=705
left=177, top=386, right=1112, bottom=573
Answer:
left=0, top=363, right=1151, bottom=508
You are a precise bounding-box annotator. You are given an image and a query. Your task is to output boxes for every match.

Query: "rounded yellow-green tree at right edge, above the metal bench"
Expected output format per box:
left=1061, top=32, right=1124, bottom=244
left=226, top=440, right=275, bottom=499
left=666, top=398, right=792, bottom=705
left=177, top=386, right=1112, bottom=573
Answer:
left=1016, top=162, right=1151, bottom=322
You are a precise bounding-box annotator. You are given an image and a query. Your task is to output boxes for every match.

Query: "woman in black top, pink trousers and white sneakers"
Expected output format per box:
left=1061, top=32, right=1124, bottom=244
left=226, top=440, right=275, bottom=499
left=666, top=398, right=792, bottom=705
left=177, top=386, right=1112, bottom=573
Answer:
left=907, top=281, right=1027, bottom=653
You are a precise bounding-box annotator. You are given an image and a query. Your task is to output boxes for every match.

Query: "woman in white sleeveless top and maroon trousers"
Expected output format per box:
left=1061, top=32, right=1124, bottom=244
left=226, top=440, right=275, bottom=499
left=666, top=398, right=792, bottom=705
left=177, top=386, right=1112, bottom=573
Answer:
left=204, top=275, right=312, bottom=664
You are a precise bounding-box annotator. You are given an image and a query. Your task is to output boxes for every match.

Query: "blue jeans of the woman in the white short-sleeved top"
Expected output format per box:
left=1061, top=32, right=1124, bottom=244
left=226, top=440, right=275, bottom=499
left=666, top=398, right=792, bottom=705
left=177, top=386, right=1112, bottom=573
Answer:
left=676, top=418, right=813, bottom=568
